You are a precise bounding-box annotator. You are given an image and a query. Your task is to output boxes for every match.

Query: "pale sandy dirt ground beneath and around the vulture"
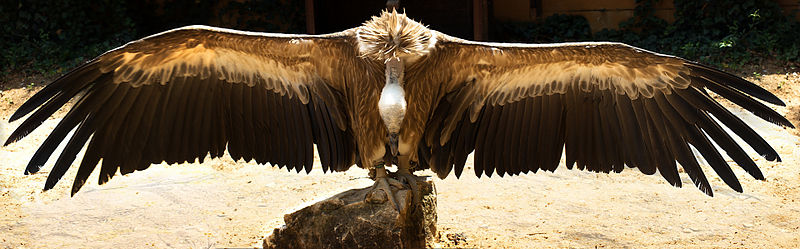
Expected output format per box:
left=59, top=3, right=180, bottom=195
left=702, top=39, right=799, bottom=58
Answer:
left=0, top=66, right=800, bottom=248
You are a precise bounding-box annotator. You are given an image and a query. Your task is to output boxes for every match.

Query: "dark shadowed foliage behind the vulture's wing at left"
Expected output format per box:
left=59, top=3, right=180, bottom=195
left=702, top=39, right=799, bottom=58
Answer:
left=0, top=0, right=305, bottom=77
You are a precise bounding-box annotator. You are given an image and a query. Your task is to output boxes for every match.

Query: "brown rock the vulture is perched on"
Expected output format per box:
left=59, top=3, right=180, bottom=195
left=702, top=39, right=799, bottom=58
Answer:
left=264, top=180, right=437, bottom=248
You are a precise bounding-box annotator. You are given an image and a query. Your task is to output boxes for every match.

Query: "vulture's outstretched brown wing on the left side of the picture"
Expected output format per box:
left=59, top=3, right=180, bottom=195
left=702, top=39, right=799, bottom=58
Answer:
left=1, top=26, right=366, bottom=194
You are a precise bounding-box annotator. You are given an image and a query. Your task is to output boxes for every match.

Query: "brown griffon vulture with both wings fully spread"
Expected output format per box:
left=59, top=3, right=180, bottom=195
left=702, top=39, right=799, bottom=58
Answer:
left=5, top=11, right=793, bottom=208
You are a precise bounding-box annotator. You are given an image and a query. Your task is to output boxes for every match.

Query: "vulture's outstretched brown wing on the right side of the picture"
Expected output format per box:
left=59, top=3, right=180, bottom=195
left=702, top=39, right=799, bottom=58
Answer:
left=416, top=35, right=792, bottom=195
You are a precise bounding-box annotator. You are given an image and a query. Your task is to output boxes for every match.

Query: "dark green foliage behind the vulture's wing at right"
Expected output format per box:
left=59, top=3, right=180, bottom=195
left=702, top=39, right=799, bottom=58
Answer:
left=495, top=0, right=800, bottom=67
